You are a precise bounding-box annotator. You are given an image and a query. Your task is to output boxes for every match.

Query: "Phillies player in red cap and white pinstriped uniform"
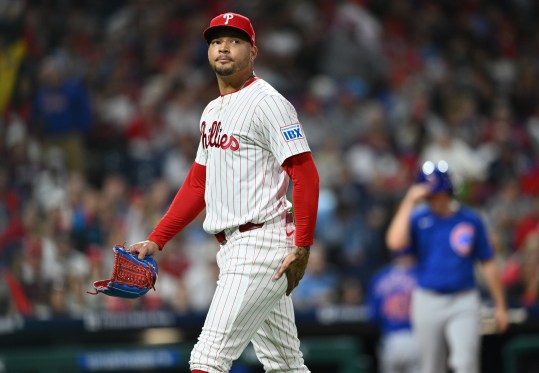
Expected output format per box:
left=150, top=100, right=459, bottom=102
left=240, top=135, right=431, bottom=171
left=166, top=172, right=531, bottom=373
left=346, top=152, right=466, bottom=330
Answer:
left=130, top=13, right=319, bottom=373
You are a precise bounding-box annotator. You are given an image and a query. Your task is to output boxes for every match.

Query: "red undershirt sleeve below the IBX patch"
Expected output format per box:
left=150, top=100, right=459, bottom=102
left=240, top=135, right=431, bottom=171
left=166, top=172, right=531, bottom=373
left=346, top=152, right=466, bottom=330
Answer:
left=282, top=152, right=320, bottom=246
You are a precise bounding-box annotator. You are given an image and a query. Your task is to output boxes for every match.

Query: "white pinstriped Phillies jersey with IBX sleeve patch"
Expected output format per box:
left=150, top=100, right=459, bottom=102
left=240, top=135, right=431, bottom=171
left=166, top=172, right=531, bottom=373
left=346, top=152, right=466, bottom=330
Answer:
left=195, top=78, right=310, bottom=234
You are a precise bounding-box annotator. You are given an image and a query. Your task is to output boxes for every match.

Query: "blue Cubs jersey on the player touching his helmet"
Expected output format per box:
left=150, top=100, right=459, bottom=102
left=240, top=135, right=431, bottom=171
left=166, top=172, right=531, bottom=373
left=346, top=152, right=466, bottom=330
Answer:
left=411, top=204, right=494, bottom=293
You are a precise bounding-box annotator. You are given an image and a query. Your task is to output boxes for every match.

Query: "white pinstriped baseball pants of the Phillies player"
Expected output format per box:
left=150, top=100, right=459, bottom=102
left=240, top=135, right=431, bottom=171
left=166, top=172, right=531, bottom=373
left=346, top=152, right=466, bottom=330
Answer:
left=190, top=218, right=309, bottom=373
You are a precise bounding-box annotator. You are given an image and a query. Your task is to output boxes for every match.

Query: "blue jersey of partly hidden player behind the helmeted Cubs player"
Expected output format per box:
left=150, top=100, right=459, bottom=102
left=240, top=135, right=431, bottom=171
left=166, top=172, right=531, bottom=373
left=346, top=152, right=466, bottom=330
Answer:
left=367, top=264, right=417, bottom=335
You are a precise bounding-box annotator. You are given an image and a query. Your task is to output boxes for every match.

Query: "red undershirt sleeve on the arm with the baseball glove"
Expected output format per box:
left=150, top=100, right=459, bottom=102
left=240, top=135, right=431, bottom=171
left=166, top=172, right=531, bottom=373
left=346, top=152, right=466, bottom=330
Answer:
left=148, top=162, right=206, bottom=250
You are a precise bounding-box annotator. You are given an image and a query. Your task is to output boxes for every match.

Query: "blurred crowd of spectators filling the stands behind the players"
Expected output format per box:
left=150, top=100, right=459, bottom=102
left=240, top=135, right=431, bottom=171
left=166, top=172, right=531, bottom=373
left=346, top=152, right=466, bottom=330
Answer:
left=0, top=0, right=539, bottom=318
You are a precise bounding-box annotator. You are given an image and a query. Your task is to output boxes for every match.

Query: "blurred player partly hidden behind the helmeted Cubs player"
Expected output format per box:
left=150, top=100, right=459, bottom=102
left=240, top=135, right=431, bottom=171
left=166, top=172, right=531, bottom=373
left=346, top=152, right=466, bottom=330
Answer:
left=367, top=249, right=419, bottom=373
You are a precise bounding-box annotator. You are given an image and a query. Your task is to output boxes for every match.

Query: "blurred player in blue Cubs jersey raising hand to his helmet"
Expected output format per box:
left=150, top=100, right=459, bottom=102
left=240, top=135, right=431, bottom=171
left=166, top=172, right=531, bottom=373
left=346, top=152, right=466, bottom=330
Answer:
left=386, top=161, right=508, bottom=373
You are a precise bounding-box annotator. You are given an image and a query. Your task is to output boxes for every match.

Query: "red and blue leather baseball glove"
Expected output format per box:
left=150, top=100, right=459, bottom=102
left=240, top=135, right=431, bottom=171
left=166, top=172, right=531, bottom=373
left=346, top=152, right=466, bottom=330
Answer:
left=87, top=245, right=158, bottom=298
